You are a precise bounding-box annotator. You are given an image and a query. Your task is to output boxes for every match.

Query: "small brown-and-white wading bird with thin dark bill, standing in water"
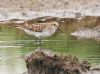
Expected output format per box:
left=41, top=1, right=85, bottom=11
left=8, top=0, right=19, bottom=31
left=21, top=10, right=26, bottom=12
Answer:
left=16, top=21, right=61, bottom=49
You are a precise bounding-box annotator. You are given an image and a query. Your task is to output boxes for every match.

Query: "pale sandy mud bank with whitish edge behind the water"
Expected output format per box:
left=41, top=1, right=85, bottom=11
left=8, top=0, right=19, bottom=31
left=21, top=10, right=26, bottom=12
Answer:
left=0, top=0, right=100, bottom=21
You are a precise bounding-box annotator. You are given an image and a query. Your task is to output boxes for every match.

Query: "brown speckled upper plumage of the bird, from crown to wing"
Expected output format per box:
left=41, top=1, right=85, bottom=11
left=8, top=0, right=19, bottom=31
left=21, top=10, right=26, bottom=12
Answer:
left=24, top=21, right=59, bottom=32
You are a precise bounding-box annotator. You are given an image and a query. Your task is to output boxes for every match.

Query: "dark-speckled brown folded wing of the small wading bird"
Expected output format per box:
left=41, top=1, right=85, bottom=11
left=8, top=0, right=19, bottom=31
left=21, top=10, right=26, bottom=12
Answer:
left=25, top=23, right=46, bottom=32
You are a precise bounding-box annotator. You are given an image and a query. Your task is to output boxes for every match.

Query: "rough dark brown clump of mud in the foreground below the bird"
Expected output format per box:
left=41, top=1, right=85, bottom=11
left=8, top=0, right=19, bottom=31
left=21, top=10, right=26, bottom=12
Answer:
left=25, top=51, right=91, bottom=74
